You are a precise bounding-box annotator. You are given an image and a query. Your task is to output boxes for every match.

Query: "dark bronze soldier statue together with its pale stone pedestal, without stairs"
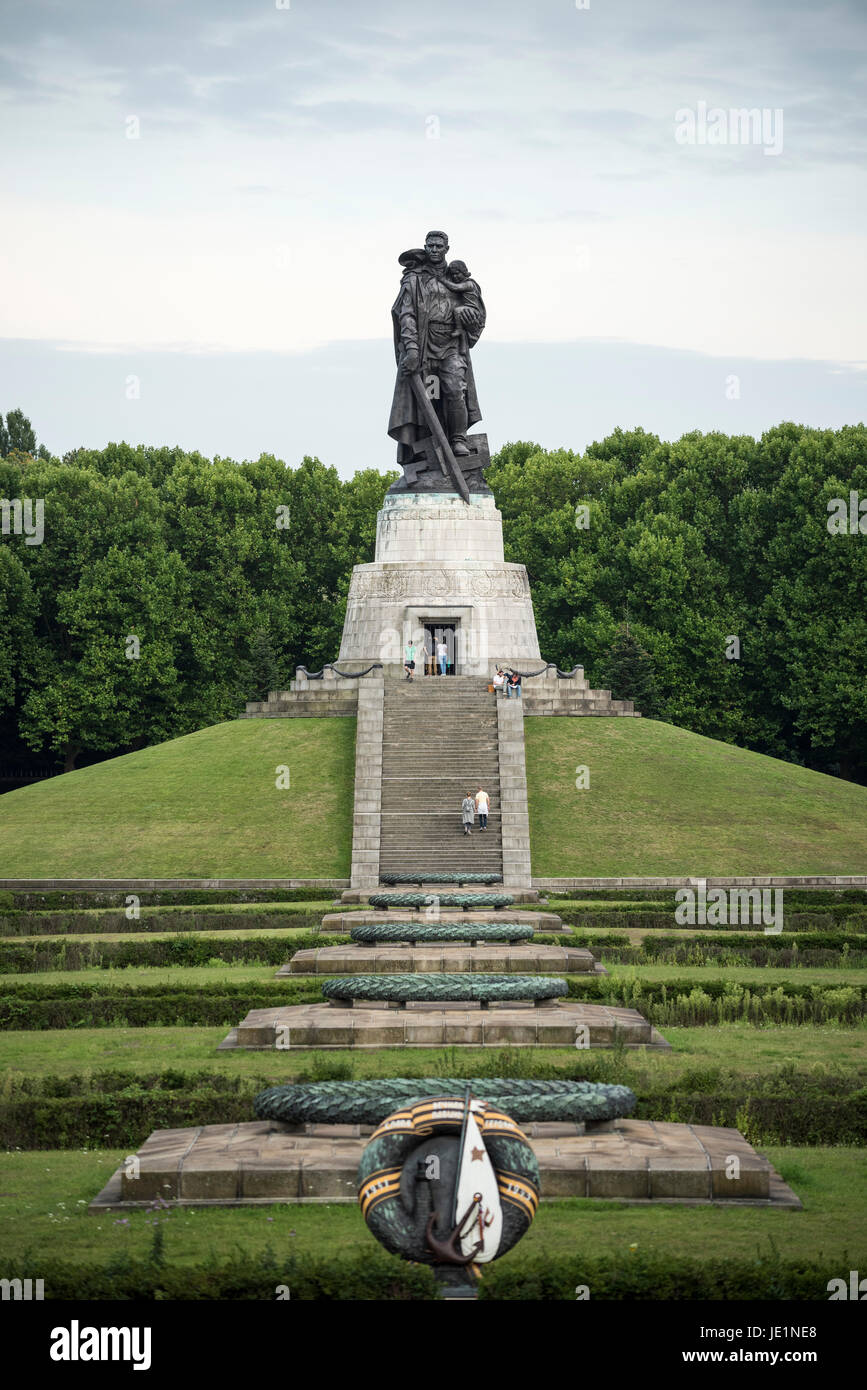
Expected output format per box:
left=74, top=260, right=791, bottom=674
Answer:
left=338, top=231, right=540, bottom=676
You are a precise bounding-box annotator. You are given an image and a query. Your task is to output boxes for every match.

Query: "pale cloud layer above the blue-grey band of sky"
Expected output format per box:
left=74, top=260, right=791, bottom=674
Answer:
left=0, top=0, right=867, bottom=360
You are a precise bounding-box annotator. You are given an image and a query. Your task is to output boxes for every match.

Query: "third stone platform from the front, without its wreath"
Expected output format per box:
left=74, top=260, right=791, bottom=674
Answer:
left=276, top=941, right=609, bottom=980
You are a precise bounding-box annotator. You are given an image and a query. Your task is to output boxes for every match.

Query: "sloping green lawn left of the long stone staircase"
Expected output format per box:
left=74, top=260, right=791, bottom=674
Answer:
left=0, top=719, right=356, bottom=878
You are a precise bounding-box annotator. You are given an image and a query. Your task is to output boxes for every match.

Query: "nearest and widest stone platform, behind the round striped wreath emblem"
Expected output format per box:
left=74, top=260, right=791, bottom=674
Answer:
left=89, top=1119, right=800, bottom=1215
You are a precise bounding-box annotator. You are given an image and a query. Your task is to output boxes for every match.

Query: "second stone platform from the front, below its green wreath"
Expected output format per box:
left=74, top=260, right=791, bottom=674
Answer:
left=220, top=999, right=668, bottom=1052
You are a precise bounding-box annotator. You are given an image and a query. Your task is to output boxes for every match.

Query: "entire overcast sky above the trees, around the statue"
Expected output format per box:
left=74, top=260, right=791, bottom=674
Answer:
left=0, top=0, right=867, bottom=473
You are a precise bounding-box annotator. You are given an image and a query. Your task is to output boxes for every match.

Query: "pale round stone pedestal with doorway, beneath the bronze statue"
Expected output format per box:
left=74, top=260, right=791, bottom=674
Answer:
left=338, top=492, right=540, bottom=678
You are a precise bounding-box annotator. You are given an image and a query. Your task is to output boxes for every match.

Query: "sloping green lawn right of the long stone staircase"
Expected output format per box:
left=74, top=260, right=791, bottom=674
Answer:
left=524, top=717, right=867, bottom=877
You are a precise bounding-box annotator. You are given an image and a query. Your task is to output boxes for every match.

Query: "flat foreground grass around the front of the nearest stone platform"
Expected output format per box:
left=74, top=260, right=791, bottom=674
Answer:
left=0, top=1148, right=867, bottom=1272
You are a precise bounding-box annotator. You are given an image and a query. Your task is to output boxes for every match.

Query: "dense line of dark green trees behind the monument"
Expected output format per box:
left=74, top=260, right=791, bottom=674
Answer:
left=0, top=411, right=867, bottom=783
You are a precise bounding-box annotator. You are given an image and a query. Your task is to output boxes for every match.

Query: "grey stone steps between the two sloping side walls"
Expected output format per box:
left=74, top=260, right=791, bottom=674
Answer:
left=379, top=676, right=503, bottom=874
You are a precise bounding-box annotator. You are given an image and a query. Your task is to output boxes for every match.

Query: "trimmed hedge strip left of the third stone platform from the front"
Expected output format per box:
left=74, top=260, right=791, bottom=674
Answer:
left=0, top=933, right=346, bottom=974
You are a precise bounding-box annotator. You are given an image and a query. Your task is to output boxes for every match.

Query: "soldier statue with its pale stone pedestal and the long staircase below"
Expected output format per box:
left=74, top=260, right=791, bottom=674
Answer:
left=246, top=222, right=636, bottom=884
